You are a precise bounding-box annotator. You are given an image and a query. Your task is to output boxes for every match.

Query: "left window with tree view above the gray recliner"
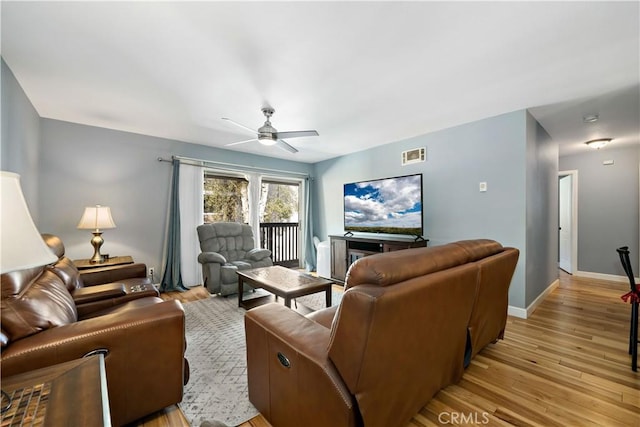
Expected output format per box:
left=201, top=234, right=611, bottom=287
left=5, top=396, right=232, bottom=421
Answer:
left=203, top=171, right=249, bottom=223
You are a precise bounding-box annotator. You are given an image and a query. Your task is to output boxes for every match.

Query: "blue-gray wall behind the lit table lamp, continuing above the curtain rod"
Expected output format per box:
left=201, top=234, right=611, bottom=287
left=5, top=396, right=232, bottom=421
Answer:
left=39, top=119, right=311, bottom=271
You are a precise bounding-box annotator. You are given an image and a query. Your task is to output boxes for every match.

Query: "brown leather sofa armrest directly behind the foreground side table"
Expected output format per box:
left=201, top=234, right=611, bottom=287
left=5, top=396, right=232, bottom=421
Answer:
left=0, top=298, right=186, bottom=425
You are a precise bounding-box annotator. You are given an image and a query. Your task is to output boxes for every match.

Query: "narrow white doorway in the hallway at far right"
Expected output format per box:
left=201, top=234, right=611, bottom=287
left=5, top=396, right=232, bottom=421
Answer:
left=558, top=170, right=578, bottom=274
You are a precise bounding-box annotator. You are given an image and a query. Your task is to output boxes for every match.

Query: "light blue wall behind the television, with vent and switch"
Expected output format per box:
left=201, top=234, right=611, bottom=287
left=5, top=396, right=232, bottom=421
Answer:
left=314, top=111, right=536, bottom=307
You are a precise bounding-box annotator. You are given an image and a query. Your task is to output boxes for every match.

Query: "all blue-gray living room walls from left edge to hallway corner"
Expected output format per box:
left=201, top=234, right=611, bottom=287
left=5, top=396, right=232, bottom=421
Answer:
left=2, top=57, right=557, bottom=308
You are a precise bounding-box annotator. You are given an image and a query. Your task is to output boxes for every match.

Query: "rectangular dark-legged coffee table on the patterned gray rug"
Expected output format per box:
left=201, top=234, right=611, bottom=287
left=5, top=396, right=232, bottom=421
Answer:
left=237, top=265, right=333, bottom=309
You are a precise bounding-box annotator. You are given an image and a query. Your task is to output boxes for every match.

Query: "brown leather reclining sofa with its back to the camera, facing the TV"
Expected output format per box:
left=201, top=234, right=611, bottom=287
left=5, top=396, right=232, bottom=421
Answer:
left=245, top=240, right=519, bottom=427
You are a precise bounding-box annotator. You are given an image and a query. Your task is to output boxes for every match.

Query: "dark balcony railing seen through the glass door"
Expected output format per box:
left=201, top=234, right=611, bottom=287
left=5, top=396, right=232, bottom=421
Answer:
left=260, top=222, right=300, bottom=267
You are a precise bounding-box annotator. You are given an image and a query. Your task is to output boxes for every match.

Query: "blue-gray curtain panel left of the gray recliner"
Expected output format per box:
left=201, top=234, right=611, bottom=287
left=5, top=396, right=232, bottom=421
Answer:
left=160, top=158, right=187, bottom=292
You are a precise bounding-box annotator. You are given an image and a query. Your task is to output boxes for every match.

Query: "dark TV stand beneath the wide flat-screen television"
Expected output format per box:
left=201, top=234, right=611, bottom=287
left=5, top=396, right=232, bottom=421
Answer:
left=329, top=233, right=429, bottom=282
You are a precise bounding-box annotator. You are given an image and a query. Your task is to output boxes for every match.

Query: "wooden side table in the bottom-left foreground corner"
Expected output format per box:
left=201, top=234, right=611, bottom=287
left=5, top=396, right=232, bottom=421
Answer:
left=2, top=354, right=111, bottom=427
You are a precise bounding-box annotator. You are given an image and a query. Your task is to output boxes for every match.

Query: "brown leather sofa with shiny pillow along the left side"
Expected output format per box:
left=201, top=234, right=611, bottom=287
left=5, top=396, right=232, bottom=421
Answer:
left=0, top=235, right=188, bottom=426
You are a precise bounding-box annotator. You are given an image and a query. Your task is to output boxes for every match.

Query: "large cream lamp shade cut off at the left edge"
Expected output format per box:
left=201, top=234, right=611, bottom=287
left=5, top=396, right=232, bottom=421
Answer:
left=0, top=171, right=58, bottom=273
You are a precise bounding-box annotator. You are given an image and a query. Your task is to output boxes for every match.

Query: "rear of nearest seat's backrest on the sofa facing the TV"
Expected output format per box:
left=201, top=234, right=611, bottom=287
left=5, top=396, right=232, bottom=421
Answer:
left=329, top=264, right=478, bottom=426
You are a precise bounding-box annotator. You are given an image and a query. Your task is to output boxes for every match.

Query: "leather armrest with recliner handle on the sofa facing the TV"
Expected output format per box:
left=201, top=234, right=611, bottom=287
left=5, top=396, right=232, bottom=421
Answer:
left=245, top=303, right=357, bottom=426
